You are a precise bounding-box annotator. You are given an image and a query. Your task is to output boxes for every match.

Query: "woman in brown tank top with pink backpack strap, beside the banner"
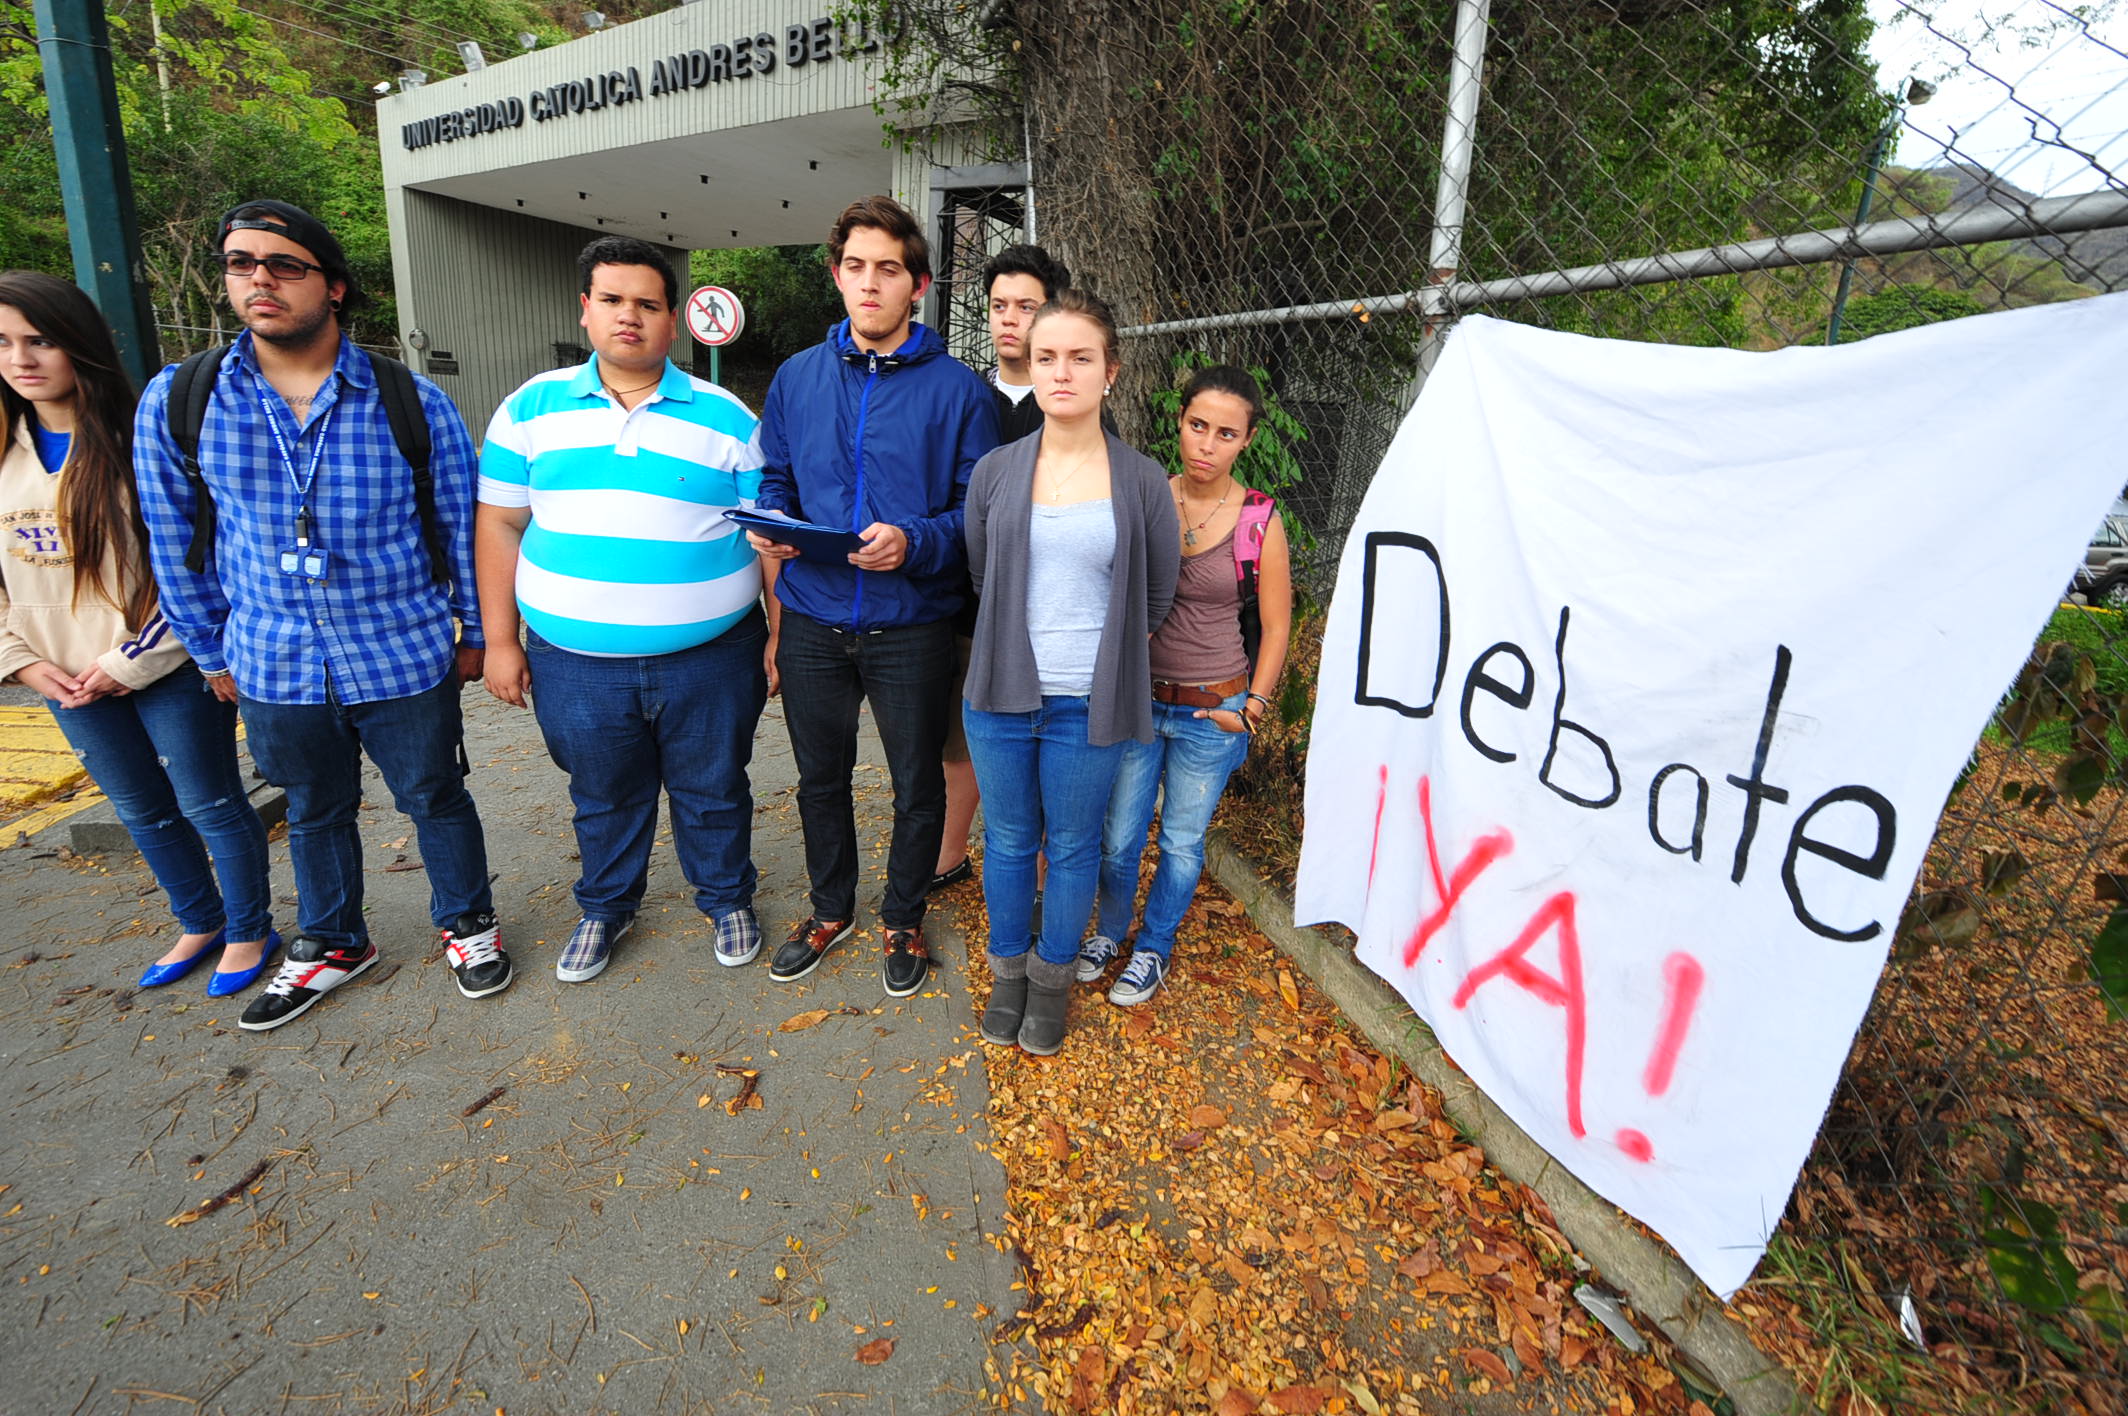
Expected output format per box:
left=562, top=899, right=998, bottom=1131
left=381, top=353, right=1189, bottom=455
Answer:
left=1079, top=364, right=1294, bottom=1007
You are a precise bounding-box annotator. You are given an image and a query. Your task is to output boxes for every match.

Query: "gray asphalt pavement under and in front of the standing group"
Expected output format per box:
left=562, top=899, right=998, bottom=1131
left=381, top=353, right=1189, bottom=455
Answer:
left=0, top=690, right=1017, bottom=1416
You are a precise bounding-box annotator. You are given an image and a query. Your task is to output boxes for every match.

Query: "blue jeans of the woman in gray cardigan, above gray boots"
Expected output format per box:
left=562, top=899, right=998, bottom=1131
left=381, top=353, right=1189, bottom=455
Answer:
left=962, top=696, right=1130, bottom=965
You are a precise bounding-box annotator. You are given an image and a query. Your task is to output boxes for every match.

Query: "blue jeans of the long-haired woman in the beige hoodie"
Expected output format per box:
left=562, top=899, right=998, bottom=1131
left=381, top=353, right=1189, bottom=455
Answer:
left=45, top=664, right=272, bottom=941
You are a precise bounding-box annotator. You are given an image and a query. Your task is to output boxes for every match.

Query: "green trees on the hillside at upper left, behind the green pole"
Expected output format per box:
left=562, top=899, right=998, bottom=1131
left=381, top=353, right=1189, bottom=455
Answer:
left=0, top=0, right=664, bottom=358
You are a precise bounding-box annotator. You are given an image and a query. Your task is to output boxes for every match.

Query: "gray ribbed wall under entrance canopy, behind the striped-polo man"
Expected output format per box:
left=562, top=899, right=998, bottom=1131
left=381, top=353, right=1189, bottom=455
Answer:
left=389, top=190, right=692, bottom=430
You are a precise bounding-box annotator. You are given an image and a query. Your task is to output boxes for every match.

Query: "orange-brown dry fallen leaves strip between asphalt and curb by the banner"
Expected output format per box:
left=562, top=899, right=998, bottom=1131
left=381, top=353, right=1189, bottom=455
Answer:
left=960, top=851, right=1685, bottom=1416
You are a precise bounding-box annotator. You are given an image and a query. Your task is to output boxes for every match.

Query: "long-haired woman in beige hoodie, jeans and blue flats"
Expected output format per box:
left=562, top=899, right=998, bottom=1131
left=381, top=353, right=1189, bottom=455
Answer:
left=0, top=270, right=279, bottom=997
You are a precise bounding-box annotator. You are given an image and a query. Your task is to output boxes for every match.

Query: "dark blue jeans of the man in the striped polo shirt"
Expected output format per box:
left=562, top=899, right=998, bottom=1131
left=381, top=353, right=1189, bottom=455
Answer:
left=526, top=609, right=768, bottom=924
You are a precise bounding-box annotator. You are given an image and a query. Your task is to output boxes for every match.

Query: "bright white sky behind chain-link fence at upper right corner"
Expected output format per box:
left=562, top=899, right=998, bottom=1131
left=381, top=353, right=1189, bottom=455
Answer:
left=1871, top=0, right=2128, bottom=196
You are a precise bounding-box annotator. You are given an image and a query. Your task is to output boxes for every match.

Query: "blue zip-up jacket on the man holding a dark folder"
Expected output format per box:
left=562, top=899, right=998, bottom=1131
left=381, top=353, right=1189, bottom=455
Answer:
left=760, top=319, right=998, bottom=630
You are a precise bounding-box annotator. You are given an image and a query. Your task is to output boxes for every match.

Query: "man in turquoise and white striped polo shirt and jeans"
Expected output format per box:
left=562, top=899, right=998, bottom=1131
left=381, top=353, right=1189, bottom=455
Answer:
left=475, top=236, right=775, bottom=984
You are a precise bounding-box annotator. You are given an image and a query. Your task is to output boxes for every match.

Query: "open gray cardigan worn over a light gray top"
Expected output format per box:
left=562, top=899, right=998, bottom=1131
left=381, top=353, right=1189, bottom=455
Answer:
left=966, top=430, right=1183, bottom=747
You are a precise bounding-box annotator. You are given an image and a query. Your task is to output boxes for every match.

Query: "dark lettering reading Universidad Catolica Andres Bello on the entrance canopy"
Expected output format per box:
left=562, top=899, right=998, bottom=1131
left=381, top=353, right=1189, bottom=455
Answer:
left=400, top=13, right=900, bottom=151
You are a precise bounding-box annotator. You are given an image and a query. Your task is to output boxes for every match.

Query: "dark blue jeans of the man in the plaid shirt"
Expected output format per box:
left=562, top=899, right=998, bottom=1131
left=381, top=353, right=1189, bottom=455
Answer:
left=238, top=669, right=496, bottom=948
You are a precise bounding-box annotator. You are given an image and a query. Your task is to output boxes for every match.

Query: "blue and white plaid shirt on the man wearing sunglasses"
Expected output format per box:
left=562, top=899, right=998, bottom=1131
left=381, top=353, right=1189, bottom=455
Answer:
left=134, top=332, right=483, bottom=703
